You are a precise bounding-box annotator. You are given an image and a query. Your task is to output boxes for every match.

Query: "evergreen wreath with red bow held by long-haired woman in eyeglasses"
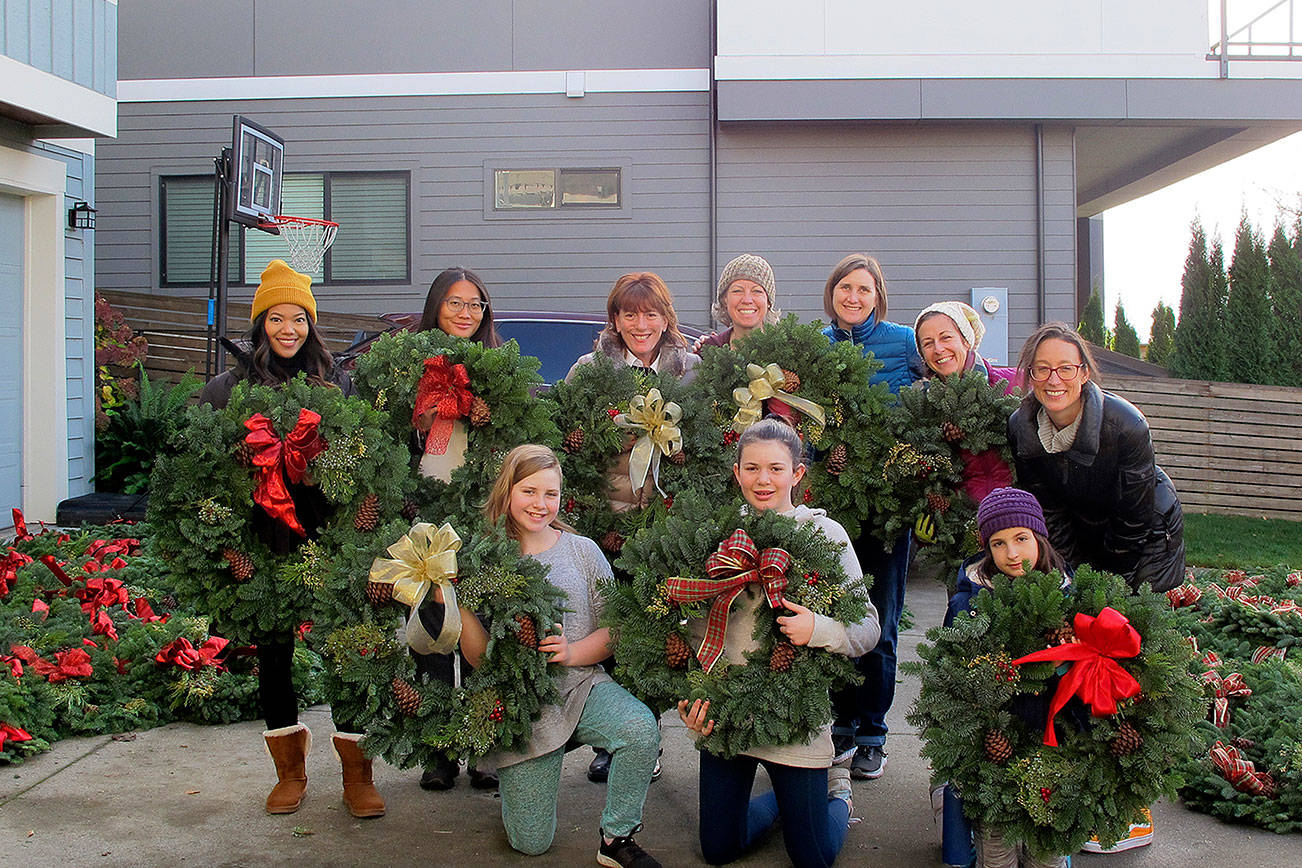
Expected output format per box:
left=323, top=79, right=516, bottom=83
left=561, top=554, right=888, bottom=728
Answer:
left=353, top=329, right=560, bottom=527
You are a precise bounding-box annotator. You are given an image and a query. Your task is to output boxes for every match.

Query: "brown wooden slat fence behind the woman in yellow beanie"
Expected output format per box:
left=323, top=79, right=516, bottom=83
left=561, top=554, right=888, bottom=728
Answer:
left=100, top=290, right=388, bottom=383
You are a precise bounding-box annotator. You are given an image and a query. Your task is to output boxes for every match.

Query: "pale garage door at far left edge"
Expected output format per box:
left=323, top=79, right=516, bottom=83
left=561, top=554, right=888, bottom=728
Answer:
left=0, top=194, right=23, bottom=512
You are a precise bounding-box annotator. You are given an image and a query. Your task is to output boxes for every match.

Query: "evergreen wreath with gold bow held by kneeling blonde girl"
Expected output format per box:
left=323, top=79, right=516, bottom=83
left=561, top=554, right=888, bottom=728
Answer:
left=312, top=522, right=564, bottom=768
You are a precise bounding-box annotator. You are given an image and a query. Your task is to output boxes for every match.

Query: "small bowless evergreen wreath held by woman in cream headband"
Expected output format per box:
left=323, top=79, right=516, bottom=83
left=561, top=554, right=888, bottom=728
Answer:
left=879, top=370, right=1018, bottom=575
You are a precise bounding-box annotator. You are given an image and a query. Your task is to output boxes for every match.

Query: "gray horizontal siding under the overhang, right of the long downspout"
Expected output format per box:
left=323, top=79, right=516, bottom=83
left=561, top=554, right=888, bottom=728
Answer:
left=719, top=124, right=1075, bottom=346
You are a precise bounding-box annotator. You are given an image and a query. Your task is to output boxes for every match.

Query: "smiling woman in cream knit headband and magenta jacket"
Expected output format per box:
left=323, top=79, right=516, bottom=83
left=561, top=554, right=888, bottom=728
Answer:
left=913, top=302, right=1022, bottom=504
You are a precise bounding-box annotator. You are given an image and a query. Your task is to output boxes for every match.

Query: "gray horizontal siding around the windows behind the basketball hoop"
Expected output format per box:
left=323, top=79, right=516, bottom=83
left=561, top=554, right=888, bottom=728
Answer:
left=96, top=92, right=711, bottom=323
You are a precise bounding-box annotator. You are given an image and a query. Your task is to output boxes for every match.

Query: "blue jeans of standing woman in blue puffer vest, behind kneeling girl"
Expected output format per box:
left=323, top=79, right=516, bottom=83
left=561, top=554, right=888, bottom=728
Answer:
left=832, top=532, right=913, bottom=747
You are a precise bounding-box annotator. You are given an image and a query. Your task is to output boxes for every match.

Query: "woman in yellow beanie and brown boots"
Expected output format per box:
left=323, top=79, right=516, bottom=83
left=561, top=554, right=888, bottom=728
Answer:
left=199, top=259, right=384, bottom=817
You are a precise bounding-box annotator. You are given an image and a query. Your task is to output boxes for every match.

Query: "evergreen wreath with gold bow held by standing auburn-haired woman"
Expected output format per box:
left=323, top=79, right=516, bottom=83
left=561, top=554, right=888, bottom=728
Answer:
left=544, top=353, right=732, bottom=560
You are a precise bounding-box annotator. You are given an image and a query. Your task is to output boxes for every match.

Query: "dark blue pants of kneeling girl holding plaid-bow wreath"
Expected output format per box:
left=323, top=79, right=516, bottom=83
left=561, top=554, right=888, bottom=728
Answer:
left=698, top=751, right=850, bottom=868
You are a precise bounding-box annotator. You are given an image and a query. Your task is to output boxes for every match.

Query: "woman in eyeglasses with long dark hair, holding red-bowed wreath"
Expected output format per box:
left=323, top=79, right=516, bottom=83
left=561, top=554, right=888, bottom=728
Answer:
left=411, top=265, right=503, bottom=790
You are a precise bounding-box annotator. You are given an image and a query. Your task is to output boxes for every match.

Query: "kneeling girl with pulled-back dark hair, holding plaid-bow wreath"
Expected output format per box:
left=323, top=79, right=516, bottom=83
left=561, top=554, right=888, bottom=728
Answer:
left=678, top=419, right=881, bottom=868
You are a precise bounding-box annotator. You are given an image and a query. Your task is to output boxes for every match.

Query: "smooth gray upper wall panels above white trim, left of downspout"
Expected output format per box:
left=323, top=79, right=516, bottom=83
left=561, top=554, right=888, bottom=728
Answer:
left=121, top=0, right=711, bottom=79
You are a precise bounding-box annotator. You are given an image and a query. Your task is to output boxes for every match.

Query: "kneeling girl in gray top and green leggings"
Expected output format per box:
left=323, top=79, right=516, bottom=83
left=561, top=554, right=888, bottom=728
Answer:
left=437, top=444, right=660, bottom=868
